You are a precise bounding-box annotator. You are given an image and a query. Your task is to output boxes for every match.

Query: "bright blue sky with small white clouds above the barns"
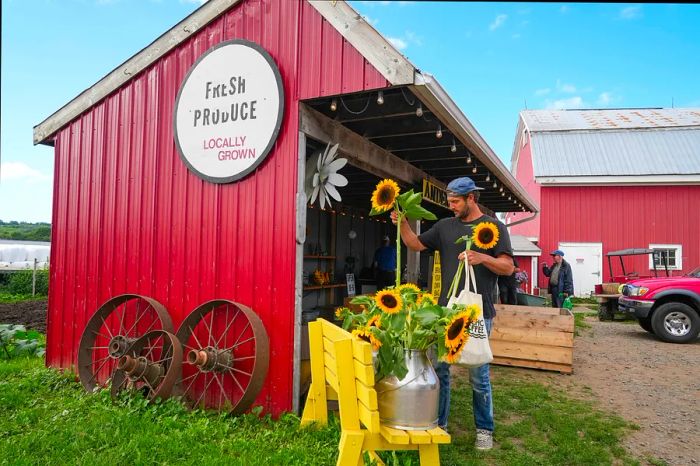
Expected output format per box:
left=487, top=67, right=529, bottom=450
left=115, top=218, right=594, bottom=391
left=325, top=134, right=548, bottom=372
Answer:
left=0, top=0, right=700, bottom=222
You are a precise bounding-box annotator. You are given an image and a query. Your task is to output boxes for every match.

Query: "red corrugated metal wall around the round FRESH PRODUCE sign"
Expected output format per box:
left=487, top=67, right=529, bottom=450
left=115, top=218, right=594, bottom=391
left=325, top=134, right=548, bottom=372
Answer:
left=46, top=0, right=388, bottom=414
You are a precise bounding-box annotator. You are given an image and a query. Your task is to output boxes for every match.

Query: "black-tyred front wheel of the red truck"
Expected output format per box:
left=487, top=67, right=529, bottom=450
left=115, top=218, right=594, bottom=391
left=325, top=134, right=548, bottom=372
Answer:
left=651, top=302, right=700, bottom=343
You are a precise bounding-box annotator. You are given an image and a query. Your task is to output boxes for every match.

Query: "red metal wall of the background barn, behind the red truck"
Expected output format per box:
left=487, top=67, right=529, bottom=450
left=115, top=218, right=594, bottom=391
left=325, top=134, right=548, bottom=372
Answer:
left=539, top=186, right=700, bottom=287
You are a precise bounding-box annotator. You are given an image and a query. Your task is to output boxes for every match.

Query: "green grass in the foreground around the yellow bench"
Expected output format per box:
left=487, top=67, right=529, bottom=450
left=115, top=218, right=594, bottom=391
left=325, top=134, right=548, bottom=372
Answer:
left=0, top=359, right=639, bottom=466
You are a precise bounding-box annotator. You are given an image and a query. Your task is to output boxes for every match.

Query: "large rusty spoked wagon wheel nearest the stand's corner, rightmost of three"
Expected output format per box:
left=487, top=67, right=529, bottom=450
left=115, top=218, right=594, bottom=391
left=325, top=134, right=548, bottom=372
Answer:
left=177, top=299, right=270, bottom=414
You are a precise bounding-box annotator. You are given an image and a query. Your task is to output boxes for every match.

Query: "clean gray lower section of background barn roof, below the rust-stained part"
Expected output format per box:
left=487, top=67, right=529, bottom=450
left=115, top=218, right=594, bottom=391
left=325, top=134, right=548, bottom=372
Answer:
left=530, top=126, right=700, bottom=177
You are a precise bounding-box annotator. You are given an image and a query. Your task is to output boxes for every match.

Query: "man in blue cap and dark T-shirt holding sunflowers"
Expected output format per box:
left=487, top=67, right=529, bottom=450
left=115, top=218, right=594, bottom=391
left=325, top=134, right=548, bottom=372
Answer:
left=391, top=177, right=513, bottom=450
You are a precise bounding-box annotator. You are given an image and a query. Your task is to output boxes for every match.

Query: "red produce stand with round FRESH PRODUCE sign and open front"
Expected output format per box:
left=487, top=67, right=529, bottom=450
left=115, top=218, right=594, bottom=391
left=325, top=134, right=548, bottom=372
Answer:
left=34, top=0, right=538, bottom=414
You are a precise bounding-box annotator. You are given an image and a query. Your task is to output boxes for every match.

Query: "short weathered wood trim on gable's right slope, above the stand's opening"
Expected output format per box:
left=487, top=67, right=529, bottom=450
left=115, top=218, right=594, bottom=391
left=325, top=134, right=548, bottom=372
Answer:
left=309, top=0, right=415, bottom=86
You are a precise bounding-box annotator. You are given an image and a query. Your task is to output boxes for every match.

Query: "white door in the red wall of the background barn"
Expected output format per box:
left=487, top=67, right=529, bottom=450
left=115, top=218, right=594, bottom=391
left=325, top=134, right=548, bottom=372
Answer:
left=559, top=243, right=603, bottom=297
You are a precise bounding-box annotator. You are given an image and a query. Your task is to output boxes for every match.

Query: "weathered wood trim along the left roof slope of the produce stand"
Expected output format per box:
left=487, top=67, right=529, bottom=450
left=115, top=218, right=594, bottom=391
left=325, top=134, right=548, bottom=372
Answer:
left=34, top=0, right=242, bottom=145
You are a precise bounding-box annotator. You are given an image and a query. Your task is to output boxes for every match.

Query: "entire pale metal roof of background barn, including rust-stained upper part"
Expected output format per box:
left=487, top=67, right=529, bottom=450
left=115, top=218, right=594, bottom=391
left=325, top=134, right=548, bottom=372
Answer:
left=514, top=108, right=700, bottom=184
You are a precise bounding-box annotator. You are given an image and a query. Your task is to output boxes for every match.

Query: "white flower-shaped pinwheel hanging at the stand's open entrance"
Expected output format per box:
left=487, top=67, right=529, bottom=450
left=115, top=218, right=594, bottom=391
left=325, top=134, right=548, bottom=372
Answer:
left=305, top=143, right=348, bottom=209
